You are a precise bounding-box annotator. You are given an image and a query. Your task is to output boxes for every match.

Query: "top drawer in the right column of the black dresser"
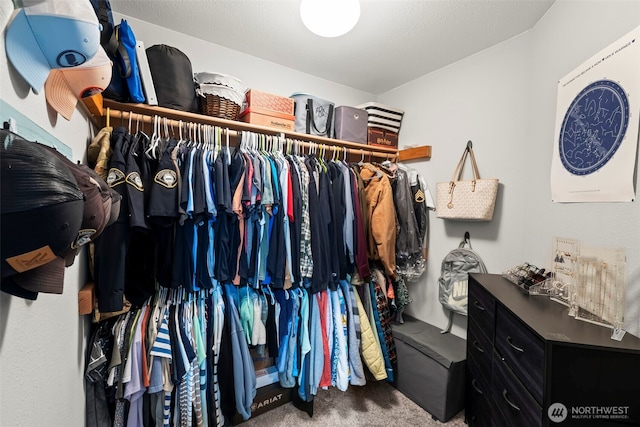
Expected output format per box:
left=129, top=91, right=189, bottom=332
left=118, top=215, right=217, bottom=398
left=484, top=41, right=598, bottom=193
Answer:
left=495, top=306, right=544, bottom=404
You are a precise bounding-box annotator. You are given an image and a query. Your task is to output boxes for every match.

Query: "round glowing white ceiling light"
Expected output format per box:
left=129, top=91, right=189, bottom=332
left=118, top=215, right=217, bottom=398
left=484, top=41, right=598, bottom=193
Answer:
left=300, top=0, right=360, bottom=37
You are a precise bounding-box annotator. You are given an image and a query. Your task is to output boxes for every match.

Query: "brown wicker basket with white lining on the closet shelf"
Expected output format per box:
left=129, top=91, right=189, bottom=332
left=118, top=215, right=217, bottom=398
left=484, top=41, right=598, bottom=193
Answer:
left=193, top=72, right=247, bottom=120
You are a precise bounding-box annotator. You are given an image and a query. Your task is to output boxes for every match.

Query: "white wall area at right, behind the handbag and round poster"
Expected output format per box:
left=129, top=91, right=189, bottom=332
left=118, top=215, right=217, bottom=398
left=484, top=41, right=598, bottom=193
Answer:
left=378, top=0, right=640, bottom=342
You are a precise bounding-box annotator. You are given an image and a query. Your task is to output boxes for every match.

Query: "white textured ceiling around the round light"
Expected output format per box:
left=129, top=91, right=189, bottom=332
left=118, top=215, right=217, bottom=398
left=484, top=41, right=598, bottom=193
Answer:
left=111, top=0, right=553, bottom=95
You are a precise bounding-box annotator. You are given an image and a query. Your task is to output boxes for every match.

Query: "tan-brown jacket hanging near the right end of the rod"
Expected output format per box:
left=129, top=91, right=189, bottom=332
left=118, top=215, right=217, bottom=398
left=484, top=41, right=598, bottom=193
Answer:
left=360, top=163, right=396, bottom=280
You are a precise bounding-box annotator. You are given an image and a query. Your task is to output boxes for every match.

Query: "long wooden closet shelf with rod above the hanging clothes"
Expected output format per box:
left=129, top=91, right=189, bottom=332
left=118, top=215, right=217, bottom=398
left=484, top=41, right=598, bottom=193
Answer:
left=83, top=94, right=431, bottom=160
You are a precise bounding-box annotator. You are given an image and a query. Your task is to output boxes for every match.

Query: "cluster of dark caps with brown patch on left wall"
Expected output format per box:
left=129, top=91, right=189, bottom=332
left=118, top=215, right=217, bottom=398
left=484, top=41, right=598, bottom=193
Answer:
left=0, top=130, right=120, bottom=300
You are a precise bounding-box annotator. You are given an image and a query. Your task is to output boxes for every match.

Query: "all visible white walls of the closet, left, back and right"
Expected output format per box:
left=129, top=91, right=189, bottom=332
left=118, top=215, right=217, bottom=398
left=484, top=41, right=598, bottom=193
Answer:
left=0, top=1, right=640, bottom=427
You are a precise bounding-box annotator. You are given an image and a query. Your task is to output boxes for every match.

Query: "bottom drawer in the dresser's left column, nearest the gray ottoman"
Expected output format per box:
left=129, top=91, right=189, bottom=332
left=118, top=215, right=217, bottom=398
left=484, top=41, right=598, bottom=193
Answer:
left=465, top=358, right=494, bottom=427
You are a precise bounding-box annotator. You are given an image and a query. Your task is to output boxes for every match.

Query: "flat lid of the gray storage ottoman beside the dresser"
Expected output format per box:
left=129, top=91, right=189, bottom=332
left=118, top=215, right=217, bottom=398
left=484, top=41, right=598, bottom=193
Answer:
left=391, top=315, right=467, bottom=369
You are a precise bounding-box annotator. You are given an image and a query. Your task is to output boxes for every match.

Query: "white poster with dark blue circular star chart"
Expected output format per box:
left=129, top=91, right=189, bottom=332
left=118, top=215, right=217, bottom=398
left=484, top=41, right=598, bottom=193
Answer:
left=551, top=27, right=640, bottom=202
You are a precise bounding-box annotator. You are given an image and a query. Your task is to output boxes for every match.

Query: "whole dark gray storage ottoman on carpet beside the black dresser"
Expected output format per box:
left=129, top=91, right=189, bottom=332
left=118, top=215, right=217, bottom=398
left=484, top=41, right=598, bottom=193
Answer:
left=392, top=315, right=466, bottom=422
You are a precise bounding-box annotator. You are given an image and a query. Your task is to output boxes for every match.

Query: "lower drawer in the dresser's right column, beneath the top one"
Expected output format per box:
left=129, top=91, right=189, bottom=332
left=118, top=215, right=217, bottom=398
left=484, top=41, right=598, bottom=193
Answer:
left=491, top=353, right=542, bottom=427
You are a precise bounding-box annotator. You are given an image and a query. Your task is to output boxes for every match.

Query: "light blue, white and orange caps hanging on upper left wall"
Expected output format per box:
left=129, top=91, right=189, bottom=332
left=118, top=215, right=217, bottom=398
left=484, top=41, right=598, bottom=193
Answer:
left=5, top=0, right=112, bottom=120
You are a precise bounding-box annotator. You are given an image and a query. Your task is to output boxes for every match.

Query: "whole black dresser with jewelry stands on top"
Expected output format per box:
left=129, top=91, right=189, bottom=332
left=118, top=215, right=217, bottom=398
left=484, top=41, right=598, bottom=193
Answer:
left=465, top=274, right=640, bottom=427
